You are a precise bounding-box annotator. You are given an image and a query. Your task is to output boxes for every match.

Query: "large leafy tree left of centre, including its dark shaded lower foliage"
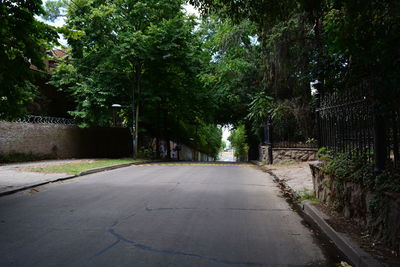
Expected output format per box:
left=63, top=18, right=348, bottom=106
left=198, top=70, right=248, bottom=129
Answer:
left=52, top=0, right=220, bottom=158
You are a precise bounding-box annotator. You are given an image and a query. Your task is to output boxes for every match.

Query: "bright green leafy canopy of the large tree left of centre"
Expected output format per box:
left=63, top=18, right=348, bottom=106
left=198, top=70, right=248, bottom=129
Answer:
left=53, top=0, right=198, bottom=126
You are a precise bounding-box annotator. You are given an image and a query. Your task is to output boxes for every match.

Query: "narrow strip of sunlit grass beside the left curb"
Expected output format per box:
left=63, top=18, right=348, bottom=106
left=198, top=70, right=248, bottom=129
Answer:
left=28, top=159, right=142, bottom=175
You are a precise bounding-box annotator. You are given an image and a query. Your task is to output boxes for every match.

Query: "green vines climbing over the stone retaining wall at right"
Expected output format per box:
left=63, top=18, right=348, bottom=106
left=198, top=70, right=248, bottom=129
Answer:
left=322, top=153, right=400, bottom=248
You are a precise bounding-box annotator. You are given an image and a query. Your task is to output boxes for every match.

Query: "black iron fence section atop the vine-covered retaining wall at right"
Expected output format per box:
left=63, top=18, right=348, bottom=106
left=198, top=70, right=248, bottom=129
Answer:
left=316, top=90, right=400, bottom=170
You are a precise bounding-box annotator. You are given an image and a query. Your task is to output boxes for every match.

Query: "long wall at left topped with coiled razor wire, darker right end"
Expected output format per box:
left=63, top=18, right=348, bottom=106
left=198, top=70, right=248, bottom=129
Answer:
left=0, top=121, right=132, bottom=158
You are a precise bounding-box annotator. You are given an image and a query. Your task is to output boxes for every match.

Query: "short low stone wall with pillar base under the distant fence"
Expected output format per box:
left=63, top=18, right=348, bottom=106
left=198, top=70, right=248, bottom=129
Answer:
left=260, top=146, right=317, bottom=163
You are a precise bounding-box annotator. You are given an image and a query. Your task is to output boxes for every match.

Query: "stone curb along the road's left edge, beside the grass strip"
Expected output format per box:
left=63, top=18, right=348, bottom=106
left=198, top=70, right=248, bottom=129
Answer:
left=0, top=161, right=153, bottom=197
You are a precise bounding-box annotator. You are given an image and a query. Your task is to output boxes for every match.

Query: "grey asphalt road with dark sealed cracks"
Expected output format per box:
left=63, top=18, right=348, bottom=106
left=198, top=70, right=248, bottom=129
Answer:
left=0, top=165, right=336, bottom=267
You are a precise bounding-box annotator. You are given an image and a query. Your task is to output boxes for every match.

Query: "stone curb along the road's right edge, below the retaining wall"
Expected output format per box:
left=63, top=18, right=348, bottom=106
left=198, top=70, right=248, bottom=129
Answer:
left=252, top=162, right=383, bottom=267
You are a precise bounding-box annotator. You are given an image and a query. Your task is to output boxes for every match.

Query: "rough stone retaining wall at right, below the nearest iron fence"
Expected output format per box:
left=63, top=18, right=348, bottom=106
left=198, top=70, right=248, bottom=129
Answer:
left=309, top=161, right=400, bottom=253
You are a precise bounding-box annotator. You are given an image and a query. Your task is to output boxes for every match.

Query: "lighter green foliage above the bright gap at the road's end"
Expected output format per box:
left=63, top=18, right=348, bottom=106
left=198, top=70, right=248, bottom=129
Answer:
left=197, top=16, right=262, bottom=124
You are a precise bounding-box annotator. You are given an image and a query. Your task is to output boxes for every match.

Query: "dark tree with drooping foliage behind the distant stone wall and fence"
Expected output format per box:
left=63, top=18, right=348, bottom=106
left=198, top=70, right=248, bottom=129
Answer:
left=193, top=0, right=320, bottom=153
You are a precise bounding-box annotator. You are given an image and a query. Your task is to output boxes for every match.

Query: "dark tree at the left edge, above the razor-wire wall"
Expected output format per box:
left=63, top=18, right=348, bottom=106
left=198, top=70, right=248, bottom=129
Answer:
left=0, top=0, right=58, bottom=119
